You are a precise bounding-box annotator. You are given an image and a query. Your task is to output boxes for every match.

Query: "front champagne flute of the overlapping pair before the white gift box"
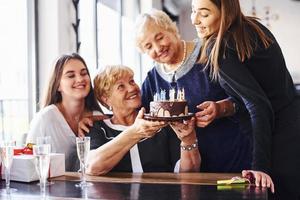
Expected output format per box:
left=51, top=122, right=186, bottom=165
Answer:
left=32, top=144, right=51, bottom=194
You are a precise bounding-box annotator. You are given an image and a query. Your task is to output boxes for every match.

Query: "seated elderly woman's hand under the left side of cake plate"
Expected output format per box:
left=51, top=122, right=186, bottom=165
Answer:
left=130, top=108, right=167, bottom=139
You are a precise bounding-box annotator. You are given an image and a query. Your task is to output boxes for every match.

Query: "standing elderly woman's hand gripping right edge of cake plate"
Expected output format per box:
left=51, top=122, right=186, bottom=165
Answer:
left=195, top=101, right=219, bottom=127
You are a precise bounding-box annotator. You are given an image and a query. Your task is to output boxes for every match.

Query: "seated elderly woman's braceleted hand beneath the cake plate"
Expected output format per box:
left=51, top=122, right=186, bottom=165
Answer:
left=170, top=117, right=197, bottom=144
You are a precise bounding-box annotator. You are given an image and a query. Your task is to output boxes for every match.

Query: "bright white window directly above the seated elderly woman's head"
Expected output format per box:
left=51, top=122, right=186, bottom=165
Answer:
left=97, top=0, right=147, bottom=84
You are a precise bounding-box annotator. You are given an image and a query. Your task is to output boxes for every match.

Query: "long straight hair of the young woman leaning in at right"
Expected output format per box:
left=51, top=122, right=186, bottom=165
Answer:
left=200, top=0, right=272, bottom=80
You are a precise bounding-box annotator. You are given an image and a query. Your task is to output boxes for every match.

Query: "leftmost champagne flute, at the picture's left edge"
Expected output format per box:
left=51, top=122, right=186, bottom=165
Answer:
left=0, top=141, right=17, bottom=194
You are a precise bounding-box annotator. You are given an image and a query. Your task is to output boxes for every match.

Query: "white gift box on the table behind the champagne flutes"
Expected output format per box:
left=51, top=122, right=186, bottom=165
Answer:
left=2, top=152, right=65, bottom=182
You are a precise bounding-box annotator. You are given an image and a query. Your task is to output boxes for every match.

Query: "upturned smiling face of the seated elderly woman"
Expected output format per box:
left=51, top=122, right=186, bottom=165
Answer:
left=105, top=74, right=141, bottom=113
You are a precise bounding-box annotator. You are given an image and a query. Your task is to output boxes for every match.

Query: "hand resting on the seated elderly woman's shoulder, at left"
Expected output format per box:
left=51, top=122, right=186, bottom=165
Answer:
left=78, top=115, right=108, bottom=137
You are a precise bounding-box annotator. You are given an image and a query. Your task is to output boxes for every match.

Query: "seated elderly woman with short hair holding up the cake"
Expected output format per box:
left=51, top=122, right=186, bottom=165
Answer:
left=87, top=66, right=200, bottom=175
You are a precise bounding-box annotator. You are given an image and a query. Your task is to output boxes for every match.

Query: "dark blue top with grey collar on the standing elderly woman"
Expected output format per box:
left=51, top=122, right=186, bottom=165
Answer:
left=142, top=41, right=252, bottom=172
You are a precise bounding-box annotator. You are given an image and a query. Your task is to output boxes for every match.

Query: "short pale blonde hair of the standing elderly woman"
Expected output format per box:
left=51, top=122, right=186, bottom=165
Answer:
left=134, top=9, right=180, bottom=51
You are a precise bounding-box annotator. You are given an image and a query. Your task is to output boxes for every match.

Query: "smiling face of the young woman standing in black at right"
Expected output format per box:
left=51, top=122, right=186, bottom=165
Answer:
left=191, top=0, right=221, bottom=38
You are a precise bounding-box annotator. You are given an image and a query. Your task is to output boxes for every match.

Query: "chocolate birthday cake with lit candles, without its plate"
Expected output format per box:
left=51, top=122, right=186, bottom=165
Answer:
left=150, top=88, right=188, bottom=117
